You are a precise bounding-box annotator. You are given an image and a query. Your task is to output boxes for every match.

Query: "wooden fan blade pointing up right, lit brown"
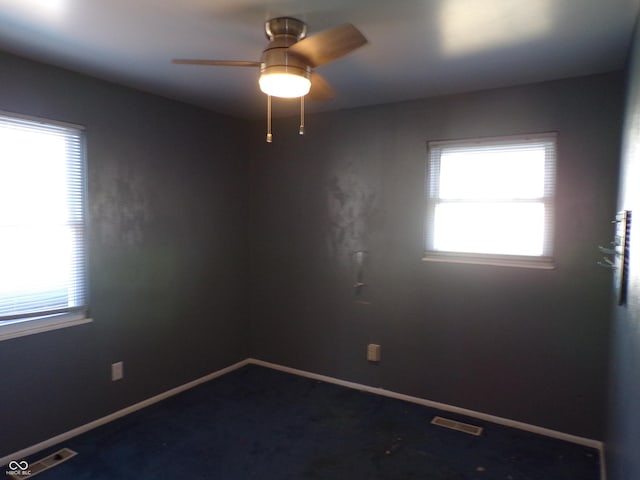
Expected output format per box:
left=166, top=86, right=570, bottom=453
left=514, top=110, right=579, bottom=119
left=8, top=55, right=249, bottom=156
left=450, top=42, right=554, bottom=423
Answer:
left=289, top=23, right=367, bottom=67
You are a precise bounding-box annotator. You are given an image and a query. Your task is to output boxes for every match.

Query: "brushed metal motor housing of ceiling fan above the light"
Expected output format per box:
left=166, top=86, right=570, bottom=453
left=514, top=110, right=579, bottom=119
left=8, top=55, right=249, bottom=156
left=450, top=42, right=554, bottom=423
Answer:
left=260, top=17, right=311, bottom=79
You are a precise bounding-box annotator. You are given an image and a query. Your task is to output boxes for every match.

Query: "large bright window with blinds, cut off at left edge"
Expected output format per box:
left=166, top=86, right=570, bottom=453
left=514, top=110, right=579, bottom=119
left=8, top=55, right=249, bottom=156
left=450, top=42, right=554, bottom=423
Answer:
left=0, top=110, right=87, bottom=338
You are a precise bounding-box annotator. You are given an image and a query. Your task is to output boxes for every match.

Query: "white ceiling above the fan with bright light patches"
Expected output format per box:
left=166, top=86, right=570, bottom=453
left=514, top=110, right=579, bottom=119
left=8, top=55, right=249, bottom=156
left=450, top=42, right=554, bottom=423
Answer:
left=0, top=0, right=640, bottom=117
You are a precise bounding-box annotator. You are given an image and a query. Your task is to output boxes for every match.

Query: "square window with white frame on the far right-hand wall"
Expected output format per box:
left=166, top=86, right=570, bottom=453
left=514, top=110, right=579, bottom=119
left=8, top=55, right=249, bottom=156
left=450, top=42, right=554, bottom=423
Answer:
left=424, top=134, right=556, bottom=268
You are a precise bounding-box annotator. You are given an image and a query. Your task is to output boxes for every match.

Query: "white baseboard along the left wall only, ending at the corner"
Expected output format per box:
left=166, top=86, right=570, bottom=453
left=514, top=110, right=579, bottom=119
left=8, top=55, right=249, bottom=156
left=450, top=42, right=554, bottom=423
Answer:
left=0, top=359, right=249, bottom=465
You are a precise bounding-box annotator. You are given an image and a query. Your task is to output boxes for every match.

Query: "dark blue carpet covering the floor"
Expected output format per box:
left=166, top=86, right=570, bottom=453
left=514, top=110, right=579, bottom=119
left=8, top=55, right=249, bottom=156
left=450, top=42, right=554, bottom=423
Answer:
left=10, top=366, right=599, bottom=480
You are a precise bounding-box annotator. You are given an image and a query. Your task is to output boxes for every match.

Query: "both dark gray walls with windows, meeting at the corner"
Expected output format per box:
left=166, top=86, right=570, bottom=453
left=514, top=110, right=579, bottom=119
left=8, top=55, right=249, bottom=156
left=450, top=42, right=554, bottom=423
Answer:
left=0, top=46, right=622, bottom=462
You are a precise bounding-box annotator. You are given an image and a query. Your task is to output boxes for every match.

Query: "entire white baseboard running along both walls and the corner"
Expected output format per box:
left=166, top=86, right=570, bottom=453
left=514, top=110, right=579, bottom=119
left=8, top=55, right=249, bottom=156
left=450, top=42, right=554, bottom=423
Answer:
left=0, top=358, right=606, bottom=480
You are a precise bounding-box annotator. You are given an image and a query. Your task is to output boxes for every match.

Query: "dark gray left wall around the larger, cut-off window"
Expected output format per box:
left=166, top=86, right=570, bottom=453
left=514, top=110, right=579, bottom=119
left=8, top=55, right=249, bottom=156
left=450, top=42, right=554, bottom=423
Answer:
left=0, top=54, right=249, bottom=457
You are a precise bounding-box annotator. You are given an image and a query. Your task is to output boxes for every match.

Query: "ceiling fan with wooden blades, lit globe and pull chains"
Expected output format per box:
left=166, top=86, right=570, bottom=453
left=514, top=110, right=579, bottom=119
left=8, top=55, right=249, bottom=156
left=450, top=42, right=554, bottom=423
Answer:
left=173, top=17, right=367, bottom=143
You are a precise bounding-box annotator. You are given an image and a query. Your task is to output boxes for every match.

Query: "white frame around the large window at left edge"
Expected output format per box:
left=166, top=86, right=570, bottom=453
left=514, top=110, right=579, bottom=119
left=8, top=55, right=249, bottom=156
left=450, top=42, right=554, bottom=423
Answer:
left=0, top=111, right=92, bottom=341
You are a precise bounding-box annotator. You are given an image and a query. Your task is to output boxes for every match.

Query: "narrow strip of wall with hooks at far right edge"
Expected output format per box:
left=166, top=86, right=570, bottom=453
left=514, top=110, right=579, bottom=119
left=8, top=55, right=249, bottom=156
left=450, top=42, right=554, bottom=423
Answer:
left=607, top=14, right=640, bottom=480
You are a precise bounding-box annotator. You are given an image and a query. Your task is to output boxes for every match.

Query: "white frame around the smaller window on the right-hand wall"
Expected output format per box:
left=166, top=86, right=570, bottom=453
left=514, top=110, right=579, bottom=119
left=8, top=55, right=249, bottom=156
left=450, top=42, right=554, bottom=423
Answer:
left=423, top=132, right=557, bottom=270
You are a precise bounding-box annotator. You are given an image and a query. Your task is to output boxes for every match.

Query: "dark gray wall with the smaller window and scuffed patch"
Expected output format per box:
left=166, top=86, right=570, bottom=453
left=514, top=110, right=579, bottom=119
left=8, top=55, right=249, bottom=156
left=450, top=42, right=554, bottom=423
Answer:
left=250, top=73, right=623, bottom=439
